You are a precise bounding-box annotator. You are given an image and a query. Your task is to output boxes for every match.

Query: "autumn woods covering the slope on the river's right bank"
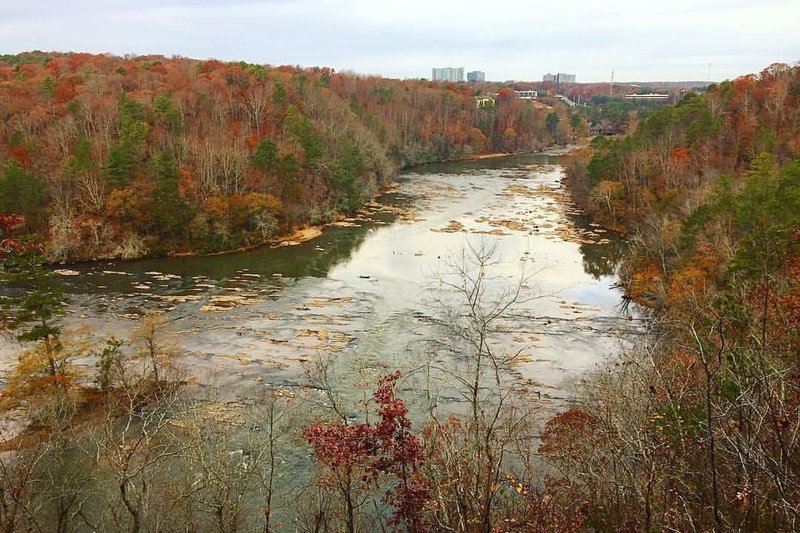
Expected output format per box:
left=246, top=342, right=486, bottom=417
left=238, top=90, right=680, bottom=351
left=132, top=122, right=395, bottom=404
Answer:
left=542, top=61, right=800, bottom=531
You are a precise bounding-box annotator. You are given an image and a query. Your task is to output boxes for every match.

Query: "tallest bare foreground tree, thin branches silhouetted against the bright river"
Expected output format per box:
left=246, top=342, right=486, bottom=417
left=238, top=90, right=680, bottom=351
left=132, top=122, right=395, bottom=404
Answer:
left=425, top=241, right=540, bottom=532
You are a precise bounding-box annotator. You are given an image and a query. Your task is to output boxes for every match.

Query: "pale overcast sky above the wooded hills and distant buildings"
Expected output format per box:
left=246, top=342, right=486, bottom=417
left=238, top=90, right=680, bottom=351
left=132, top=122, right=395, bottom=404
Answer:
left=0, top=0, right=800, bottom=82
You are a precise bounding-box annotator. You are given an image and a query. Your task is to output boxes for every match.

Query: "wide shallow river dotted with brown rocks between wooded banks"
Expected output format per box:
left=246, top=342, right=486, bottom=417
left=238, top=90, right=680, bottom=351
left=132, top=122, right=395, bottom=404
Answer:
left=0, top=150, right=639, bottom=416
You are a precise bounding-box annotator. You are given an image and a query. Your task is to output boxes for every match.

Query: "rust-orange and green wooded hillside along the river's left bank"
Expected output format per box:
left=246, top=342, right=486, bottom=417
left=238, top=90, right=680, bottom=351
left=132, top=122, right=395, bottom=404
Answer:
left=0, top=52, right=585, bottom=260
